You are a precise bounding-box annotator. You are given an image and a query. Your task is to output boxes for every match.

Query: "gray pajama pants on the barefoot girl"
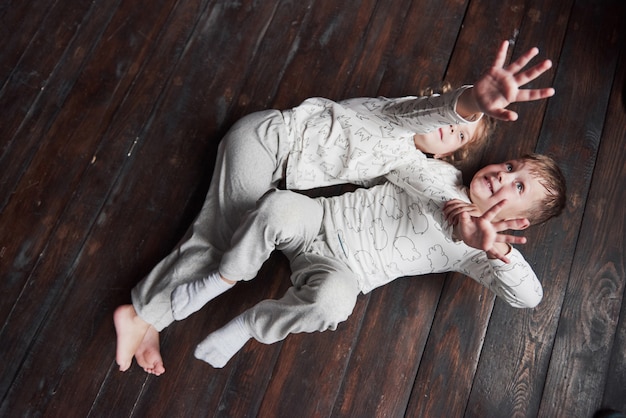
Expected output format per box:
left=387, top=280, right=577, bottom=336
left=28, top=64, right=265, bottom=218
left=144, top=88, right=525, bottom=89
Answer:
left=131, top=110, right=290, bottom=331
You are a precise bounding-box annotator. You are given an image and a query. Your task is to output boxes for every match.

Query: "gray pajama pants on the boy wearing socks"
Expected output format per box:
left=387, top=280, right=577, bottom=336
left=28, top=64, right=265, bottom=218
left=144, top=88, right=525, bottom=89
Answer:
left=219, top=191, right=360, bottom=344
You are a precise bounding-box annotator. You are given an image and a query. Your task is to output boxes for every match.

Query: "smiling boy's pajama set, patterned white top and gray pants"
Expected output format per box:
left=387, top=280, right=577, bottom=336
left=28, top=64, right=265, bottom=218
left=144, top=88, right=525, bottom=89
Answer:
left=211, top=159, right=543, bottom=344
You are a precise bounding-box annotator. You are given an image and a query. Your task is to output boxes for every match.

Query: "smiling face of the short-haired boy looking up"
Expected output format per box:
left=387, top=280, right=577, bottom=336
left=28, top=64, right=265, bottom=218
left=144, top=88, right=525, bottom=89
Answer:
left=469, top=160, right=547, bottom=221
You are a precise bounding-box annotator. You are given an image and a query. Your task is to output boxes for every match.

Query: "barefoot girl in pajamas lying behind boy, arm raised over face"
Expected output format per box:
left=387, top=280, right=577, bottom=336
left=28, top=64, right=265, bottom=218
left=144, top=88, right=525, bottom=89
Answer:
left=114, top=42, right=554, bottom=374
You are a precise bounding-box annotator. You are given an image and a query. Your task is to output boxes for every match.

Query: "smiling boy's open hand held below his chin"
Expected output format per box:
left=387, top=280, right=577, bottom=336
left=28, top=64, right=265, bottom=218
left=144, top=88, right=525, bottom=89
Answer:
left=443, top=199, right=529, bottom=263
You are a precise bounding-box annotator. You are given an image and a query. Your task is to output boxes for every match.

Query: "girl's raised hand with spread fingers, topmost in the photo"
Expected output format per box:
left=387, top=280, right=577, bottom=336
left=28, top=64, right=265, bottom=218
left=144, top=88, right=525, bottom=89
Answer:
left=456, top=41, right=554, bottom=121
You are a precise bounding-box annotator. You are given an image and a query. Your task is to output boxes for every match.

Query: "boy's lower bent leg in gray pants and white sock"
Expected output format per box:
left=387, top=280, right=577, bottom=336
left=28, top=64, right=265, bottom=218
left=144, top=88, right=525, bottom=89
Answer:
left=195, top=254, right=360, bottom=367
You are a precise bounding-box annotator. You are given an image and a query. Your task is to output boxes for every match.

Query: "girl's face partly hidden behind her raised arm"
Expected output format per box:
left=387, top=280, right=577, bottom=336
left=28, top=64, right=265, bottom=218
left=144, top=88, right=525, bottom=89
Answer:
left=413, top=123, right=479, bottom=157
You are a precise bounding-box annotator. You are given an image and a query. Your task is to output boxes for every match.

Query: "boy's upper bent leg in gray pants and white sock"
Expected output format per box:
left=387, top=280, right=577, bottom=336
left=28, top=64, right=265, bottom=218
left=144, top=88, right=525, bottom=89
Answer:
left=172, top=190, right=324, bottom=320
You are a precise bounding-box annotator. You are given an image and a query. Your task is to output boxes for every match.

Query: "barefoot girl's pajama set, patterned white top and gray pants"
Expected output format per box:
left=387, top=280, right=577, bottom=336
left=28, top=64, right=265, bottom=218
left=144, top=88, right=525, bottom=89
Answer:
left=131, top=86, right=482, bottom=331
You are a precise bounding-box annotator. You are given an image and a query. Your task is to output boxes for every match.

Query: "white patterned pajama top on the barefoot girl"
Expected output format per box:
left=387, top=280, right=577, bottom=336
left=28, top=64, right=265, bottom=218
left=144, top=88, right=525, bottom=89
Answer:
left=282, top=86, right=478, bottom=190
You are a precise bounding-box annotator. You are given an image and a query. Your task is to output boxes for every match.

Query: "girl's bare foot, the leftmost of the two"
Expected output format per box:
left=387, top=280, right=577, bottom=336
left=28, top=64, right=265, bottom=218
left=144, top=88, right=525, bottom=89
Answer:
left=113, top=305, right=150, bottom=372
